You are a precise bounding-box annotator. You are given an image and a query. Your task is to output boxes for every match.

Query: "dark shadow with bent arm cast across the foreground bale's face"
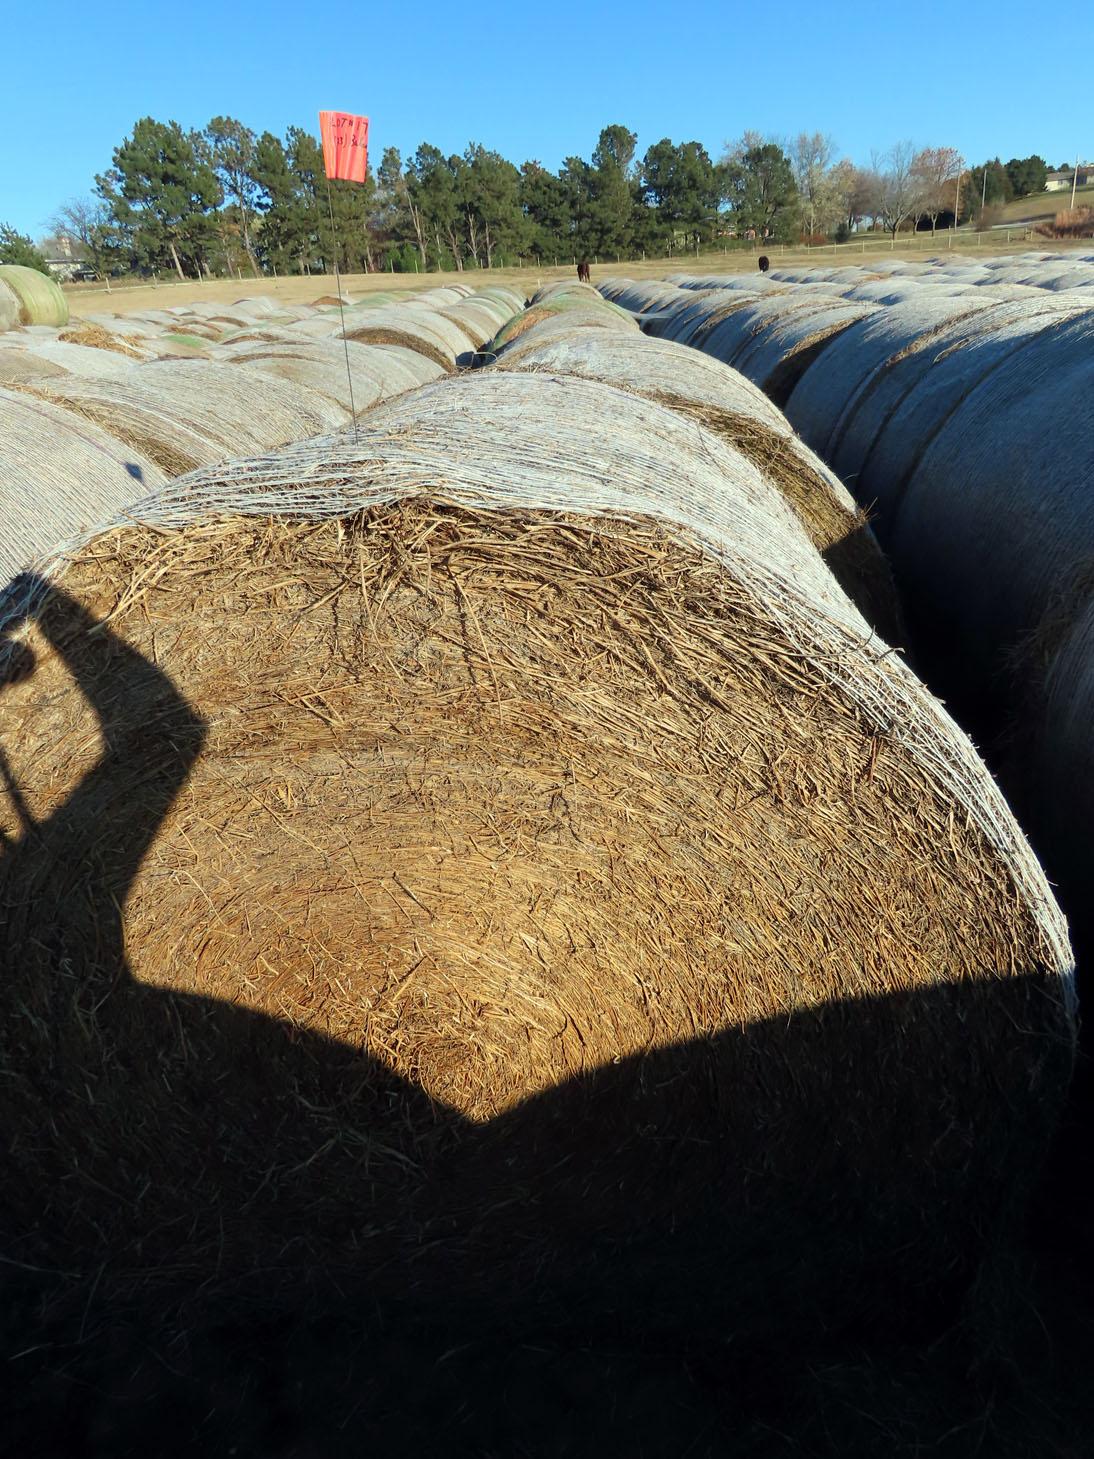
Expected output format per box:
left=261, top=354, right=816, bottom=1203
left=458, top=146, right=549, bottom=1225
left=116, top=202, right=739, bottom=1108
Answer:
left=0, top=569, right=1068, bottom=1377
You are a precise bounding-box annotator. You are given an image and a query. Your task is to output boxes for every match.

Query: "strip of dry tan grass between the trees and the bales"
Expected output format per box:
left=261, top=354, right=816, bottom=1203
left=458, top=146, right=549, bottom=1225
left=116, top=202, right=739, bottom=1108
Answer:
left=64, top=230, right=1094, bottom=318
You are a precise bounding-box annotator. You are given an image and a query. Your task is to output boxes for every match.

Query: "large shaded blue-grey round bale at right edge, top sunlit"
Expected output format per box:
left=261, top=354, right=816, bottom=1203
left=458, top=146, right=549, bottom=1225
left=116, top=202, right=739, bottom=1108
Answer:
left=881, top=305, right=1094, bottom=717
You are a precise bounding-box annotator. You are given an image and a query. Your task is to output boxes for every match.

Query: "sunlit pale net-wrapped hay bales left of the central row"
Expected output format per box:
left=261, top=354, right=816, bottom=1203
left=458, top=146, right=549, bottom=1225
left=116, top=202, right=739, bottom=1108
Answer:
left=0, top=286, right=522, bottom=588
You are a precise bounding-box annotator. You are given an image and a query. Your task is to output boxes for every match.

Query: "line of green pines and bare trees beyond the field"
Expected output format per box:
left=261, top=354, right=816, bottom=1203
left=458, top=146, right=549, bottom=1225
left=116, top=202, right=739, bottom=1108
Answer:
left=0, top=117, right=1073, bottom=279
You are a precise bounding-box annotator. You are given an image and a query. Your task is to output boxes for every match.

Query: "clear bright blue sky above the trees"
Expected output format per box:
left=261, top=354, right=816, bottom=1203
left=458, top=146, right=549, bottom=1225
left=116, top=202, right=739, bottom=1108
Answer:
left=0, top=0, right=1094, bottom=236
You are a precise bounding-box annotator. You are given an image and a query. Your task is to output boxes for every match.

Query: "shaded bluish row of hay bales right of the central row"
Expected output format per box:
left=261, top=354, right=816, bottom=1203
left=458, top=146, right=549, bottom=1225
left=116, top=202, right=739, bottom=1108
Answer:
left=600, top=258, right=1094, bottom=986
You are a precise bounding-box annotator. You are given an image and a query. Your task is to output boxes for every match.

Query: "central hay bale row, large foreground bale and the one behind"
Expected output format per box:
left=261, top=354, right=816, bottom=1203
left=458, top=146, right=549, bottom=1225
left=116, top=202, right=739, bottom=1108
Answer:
left=0, top=322, right=1074, bottom=1339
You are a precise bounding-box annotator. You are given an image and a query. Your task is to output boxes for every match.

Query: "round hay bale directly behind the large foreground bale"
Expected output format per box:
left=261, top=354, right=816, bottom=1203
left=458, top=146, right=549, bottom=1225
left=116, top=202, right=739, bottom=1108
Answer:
left=496, top=325, right=903, bottom=643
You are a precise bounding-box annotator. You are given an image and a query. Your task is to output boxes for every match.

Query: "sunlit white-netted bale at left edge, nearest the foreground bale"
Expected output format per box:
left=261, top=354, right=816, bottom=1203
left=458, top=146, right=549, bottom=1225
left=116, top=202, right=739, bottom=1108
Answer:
left=0, top=388, right=165, bottom=592
